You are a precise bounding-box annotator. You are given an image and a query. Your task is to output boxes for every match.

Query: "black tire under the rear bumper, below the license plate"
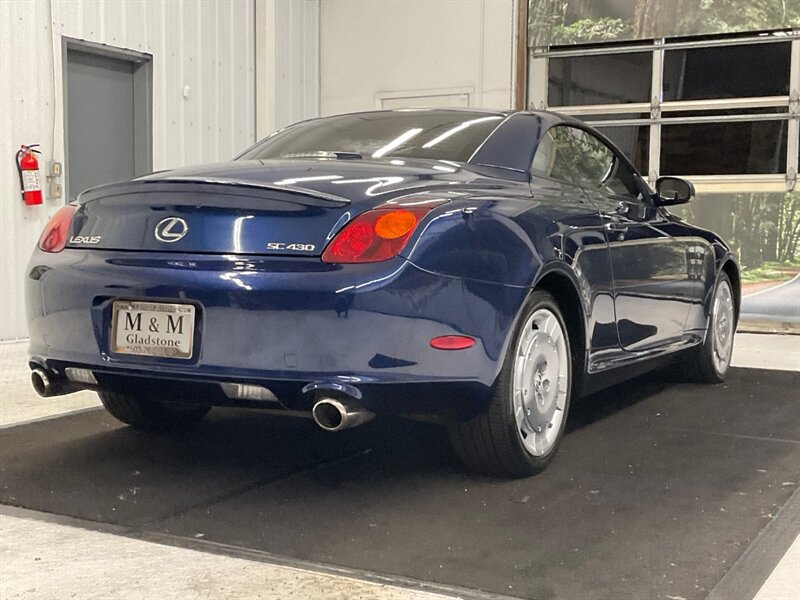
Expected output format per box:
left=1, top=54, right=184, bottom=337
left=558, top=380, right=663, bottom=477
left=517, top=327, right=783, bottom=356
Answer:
left=97, top=391, right=211, bottom=432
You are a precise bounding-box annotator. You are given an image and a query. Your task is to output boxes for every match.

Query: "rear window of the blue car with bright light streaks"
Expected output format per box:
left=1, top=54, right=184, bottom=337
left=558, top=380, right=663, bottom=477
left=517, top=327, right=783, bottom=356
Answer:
left=234, top=110, right=505, bottom=162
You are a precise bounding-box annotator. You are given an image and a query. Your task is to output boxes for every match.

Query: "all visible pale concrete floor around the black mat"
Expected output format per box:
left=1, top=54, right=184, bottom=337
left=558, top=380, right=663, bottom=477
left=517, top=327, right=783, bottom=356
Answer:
left=0, top=334, right=800, bottom=600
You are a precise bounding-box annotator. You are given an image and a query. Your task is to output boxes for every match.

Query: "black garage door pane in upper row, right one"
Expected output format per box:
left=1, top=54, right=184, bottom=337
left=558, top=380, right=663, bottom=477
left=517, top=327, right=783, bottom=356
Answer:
left=664, top=42, right=791, bottom=102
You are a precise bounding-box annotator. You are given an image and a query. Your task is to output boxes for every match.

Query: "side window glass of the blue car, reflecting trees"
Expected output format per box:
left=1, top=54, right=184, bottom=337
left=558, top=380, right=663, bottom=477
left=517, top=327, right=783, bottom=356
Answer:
left=531, top=125, right=640, bottom=198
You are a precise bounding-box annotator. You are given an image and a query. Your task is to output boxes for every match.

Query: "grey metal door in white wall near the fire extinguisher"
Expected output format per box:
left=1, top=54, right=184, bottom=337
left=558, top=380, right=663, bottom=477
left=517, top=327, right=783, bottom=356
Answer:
left=64, top=46, right=152, bottom=201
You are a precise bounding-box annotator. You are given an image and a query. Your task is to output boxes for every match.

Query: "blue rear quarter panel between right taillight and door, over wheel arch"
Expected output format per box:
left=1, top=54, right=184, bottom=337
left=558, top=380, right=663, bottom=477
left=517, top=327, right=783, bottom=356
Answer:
left=407, top=190, right=618, bottom=380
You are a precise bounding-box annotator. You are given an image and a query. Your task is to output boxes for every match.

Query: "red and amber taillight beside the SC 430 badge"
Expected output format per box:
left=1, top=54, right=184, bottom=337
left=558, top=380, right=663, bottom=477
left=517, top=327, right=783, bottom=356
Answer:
left=322, top=202, right=440, bottom=263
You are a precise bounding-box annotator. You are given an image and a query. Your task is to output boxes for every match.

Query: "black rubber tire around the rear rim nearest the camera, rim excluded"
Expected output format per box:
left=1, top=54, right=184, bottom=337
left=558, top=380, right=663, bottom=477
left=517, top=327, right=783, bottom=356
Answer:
left=448, top=290, right=572, bottom=477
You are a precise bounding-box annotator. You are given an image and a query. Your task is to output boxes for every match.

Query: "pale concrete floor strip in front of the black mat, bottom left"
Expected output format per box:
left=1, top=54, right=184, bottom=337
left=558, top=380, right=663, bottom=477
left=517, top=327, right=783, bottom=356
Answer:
left=0, top=515, right=444, bottom=600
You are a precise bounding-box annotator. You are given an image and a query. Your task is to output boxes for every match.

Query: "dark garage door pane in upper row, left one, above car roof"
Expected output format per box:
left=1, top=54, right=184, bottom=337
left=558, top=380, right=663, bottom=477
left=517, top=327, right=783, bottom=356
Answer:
left=548, top=52, right=653, bottom=106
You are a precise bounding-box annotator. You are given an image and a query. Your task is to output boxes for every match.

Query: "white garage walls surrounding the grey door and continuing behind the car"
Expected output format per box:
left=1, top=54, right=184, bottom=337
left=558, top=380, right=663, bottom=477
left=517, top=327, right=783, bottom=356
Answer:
left=0, top=0, right=514, bottom=340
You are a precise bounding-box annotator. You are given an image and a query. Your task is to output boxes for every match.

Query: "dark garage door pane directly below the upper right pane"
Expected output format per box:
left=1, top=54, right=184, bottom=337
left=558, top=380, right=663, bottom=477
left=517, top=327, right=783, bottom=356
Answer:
left=661, top=121, right=788, bottom=175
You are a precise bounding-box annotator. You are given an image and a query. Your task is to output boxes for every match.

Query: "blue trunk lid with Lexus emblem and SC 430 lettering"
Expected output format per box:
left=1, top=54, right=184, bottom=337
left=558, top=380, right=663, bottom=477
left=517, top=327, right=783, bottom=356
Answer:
left=67, top=178, right=350, bottom=256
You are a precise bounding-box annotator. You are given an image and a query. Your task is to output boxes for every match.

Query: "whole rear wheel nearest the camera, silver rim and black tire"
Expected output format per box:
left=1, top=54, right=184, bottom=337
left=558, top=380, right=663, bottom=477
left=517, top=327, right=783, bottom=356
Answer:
left=449, top=290, right=572, bottom=477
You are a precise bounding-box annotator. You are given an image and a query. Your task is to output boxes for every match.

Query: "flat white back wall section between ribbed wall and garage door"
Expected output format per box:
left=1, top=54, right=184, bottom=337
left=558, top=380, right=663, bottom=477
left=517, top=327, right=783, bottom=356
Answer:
left=320, top=0, right=514, bottom=115
